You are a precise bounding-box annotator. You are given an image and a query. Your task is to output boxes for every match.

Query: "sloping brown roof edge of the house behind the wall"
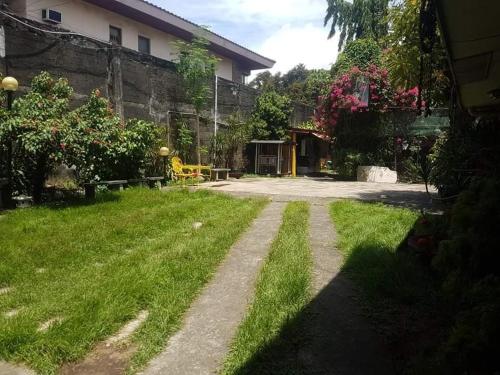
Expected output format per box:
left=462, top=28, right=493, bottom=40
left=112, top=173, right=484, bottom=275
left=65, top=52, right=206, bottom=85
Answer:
left=85, top=0, right=275, bottom=70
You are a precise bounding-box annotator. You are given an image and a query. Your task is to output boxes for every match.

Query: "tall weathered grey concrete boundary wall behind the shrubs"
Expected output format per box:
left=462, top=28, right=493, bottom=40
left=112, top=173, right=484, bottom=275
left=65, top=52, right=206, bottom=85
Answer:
left=0, top=17, right=307, bottom=168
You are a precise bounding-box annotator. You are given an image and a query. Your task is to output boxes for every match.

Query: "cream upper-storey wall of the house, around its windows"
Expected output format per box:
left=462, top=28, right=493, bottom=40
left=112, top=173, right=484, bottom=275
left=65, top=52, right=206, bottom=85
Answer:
left=9, top=0, right=234, bottom=80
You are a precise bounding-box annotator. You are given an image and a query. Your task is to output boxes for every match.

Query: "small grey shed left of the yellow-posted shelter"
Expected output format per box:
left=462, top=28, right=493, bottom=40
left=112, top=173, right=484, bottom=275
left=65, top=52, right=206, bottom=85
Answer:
left=251, top=139, right=290, bottom=176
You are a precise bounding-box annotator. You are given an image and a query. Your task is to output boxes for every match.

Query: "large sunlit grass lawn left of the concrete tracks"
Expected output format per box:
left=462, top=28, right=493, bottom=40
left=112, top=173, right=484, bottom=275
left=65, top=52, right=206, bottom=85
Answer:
left=0, top=189, right=265, bottom=374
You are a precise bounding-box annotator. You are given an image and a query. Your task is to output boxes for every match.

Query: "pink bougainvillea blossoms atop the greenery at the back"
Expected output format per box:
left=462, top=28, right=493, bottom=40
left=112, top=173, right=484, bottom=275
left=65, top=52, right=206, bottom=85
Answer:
left=316, top=65, right=418, bottom=129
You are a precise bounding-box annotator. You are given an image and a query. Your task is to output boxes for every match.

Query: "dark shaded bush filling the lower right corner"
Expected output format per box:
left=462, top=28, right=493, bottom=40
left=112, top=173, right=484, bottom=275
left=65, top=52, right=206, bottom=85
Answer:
left=433, top=179, right=500, bottom=373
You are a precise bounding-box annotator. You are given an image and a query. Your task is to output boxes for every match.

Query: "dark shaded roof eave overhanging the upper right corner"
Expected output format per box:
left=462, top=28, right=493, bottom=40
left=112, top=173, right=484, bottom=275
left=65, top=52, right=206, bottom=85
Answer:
left=436, top=0, right=500, bottom=111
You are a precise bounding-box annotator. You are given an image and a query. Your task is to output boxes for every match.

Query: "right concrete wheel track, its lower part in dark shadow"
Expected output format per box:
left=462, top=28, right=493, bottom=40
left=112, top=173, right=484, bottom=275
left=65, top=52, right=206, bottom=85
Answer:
left=299, top=204, right=394, bottom=375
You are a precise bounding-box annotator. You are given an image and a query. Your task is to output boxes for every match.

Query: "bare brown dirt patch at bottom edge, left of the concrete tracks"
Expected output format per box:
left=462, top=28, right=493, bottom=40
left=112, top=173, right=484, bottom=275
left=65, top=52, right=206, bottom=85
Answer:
left=60, top=343, right=137, bottom=375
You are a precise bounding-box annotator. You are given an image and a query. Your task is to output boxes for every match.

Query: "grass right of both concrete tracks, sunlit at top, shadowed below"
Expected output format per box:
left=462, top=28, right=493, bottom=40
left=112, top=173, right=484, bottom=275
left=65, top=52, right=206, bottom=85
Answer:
left=331, top=201, right=443, bottom=374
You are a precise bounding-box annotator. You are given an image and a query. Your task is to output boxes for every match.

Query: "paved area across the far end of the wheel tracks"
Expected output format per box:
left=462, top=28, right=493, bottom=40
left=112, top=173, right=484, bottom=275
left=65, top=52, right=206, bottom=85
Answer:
left=201, top=177, right=435, bottom=208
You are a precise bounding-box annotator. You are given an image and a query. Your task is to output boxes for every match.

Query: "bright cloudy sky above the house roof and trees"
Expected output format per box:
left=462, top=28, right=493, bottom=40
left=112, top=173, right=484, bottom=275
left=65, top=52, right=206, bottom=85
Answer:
left=150, top=0, right=337, bottom=72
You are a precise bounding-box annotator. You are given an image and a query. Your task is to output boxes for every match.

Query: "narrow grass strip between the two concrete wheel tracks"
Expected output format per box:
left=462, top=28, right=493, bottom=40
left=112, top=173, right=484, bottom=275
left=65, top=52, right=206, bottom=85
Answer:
left=223, top=202, right=312, bottom=374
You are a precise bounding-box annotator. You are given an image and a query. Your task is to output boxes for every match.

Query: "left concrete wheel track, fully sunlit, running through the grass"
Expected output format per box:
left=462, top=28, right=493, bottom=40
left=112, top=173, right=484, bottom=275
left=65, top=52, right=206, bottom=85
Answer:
left=143, top=202, right=285, bottom=375
